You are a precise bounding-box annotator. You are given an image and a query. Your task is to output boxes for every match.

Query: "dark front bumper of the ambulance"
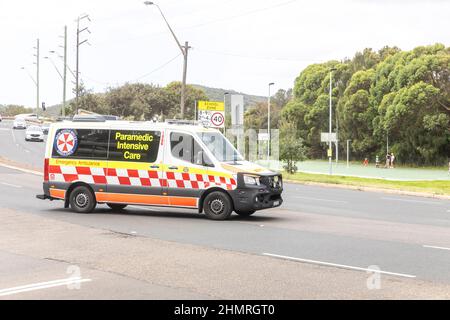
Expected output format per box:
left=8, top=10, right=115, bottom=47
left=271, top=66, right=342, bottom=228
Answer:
left=231, top=175, right=283, bottom=211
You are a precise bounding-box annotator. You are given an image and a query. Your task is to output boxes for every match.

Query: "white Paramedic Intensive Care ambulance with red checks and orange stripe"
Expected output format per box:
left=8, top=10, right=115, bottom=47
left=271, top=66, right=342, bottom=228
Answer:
left=37, top=116, right=283, bottom=220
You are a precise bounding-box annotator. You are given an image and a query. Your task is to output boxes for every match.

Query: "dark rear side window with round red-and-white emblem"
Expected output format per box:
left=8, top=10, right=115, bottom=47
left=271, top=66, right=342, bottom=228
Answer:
left=52, top=129, right=109, bottom=159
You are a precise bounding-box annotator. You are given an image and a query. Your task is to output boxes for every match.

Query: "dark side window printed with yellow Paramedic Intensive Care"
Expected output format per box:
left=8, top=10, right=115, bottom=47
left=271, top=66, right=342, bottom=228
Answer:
left=108, top=130, right=161, bottom=163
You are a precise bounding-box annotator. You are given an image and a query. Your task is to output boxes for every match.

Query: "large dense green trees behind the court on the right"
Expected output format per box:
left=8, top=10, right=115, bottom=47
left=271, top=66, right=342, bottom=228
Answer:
left=281, top=44, right=450, bottom=164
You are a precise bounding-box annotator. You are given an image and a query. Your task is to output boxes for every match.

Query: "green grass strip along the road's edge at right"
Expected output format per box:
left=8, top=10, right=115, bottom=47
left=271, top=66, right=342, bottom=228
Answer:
left=283, top=172, right=450, bottom=195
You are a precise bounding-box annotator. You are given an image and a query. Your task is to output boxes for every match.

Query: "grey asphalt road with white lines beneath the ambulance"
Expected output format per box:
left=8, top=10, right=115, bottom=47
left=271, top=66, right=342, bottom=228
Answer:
left=0, top=122, right=450, bottom=299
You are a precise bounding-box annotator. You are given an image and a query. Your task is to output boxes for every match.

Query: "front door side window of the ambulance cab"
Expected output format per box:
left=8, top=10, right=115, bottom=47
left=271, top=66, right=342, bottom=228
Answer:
left=170, top=132, right=213, bottom=166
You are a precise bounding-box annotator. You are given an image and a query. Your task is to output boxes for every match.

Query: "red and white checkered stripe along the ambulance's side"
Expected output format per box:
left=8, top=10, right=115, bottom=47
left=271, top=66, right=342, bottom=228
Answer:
left=49, top=166, right=236, bottom=190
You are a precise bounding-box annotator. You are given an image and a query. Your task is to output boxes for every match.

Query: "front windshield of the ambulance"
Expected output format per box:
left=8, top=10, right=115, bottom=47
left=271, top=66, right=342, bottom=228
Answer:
left=197, top=132, right=243, bottom=162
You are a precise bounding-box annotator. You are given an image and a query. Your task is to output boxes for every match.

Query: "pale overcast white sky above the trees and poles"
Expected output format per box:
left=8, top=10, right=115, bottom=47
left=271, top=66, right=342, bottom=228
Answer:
left=0, top=0, right=450, bottom=107
